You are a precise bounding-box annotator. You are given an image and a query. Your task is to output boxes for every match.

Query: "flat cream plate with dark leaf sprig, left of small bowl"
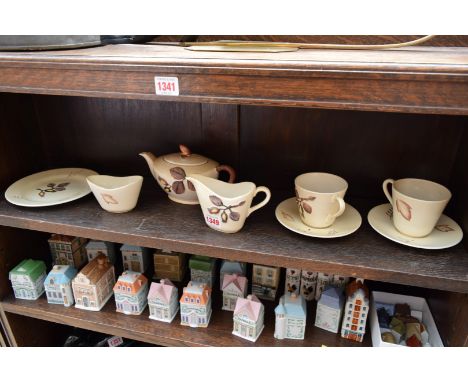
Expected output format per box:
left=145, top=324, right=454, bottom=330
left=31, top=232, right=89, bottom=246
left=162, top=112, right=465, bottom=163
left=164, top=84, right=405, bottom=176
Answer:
left=5, top=168, right=97, bottom=207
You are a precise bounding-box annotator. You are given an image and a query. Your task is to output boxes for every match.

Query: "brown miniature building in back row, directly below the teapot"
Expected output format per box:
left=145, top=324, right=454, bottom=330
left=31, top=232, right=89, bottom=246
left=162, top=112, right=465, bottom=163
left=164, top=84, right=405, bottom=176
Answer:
left=153, top=249, right=187, bottom=281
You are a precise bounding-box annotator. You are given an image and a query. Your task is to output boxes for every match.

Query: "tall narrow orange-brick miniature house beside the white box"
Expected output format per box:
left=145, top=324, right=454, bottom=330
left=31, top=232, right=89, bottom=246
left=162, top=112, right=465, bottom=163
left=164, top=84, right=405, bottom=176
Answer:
left=341, top=279, right=369, bottom=342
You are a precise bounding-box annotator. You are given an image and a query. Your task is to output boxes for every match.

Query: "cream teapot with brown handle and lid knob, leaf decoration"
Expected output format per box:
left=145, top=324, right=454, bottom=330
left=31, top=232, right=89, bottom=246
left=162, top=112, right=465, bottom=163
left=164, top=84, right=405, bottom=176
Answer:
left=140, top=145, right=236, bottom=204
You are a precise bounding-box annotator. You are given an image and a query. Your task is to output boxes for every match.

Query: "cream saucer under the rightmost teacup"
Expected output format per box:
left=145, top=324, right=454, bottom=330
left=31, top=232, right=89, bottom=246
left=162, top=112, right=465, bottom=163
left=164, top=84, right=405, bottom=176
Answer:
left=367, top=203, right=463, bottom=249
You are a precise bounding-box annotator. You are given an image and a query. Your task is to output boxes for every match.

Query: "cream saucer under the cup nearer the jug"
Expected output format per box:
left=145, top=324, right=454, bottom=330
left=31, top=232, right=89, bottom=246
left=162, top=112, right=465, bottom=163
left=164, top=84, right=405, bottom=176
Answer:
left=275, top=198, right=362, bottom=239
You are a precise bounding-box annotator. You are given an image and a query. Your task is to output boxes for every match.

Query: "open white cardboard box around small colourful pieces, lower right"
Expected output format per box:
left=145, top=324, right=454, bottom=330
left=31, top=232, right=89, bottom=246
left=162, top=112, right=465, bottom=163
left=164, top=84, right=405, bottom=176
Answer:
left=370, top=292, right=444, bottom=347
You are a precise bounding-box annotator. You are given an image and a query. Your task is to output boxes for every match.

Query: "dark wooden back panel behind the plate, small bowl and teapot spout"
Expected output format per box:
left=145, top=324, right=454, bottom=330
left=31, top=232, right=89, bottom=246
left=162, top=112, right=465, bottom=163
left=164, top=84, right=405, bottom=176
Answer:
left=34, top=96, right=204, bottom=175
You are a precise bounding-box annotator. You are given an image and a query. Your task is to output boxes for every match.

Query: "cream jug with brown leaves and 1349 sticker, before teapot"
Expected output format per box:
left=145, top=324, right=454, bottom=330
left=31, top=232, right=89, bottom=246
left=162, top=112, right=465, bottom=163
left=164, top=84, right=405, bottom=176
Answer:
left=187, top=175, right=271, bottom=233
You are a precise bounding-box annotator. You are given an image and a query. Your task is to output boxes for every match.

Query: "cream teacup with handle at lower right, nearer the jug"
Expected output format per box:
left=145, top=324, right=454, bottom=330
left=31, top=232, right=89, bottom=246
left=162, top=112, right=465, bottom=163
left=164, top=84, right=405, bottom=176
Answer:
left=294, top=172, right=348, bottom=228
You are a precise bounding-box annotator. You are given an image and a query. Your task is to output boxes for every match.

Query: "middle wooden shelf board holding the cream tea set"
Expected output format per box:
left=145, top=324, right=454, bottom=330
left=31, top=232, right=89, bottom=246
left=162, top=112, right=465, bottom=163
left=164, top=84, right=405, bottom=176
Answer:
left=0, top=185, right=468, bottom=293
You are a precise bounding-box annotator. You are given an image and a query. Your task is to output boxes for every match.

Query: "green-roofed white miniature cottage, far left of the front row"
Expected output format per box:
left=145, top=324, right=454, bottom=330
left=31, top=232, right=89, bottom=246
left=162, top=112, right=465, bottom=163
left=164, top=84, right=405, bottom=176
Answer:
left=9, top=259, right=46, bottom=300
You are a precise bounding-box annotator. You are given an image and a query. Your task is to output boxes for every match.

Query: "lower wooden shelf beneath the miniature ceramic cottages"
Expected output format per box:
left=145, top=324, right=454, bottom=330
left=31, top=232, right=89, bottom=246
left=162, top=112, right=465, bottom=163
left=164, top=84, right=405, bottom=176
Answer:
left=0, top=291, right=372, bottom=346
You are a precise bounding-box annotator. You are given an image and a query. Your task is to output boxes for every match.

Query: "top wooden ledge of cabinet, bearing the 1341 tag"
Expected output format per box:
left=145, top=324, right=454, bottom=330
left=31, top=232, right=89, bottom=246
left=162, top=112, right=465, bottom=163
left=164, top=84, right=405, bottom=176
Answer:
left=0, top=45, right=468, bottom=115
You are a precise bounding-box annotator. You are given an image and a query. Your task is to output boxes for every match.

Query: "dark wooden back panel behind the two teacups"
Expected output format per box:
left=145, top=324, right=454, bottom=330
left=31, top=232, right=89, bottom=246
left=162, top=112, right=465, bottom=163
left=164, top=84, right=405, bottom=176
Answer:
left=240, top=106, right=466, bottom=198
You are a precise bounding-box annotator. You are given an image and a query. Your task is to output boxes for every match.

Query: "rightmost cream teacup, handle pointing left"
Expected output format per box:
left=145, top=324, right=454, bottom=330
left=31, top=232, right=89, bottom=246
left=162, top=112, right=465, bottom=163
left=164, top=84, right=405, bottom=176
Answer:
left=382, top=178, right=452, bottom=237
